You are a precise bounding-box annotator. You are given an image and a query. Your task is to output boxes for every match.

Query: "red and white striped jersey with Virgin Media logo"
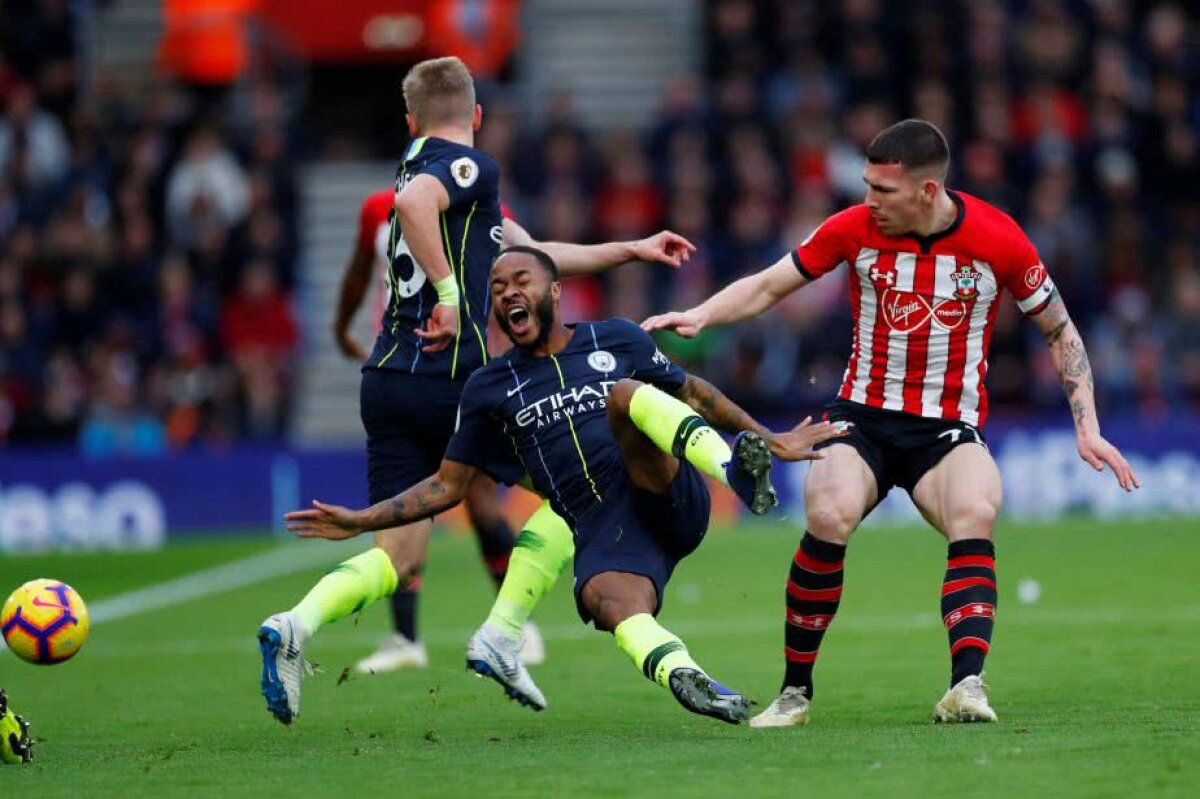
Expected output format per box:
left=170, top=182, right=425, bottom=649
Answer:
left=792, top=192, right=1054, bottom=427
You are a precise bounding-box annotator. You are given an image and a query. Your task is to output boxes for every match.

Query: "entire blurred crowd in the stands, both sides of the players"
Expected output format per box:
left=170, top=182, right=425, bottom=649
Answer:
left=0, top=0, right=1200, bottom=455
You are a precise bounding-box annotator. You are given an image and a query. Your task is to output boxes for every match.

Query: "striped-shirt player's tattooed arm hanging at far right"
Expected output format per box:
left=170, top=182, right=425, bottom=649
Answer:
left=1031, top=290, right=1141, bottom=491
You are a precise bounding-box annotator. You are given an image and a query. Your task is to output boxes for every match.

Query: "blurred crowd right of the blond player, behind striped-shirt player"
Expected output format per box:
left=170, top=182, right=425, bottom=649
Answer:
left=482, top=0, right=1200, bottom=417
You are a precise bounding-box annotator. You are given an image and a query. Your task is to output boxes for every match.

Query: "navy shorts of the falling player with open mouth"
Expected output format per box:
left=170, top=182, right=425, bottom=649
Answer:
left=574, top=461, right=712, bottom=624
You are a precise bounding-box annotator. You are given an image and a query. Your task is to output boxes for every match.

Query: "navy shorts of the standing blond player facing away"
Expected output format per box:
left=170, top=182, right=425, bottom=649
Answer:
left=359, top=368, right=463, bottom=505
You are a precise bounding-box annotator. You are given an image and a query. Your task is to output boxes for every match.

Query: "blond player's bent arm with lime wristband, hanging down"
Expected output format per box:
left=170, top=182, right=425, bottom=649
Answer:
left=396, top=175, right=458, bottom=353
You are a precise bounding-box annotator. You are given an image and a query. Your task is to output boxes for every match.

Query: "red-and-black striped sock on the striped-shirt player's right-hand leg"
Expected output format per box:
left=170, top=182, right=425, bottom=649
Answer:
left=942, top=539, right=996, bottom=687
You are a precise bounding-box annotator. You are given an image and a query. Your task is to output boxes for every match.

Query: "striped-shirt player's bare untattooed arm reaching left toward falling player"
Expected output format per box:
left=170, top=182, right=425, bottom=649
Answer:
left=642, top=254, right=808, bottom=338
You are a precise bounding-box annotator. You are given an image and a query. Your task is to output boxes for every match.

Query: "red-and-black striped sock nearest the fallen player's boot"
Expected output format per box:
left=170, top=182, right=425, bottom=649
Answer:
left=784, top=531, right=846, bottom=699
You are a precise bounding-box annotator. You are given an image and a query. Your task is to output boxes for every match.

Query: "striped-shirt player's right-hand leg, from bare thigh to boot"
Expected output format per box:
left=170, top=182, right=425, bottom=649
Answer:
left=912, top=443, right=1003, bottom=722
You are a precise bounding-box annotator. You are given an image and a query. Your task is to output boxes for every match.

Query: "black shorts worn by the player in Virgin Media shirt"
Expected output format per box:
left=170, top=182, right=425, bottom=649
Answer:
left=814, top=400, right=988, bottom=501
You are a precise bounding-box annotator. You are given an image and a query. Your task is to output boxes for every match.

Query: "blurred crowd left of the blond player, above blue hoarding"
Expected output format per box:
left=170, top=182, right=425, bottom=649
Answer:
left=0, top=0, right=299, bottom=456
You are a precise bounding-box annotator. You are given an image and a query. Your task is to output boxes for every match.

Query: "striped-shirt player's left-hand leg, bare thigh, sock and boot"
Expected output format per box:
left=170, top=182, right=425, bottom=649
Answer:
left=750, top=444, right=878, bottom=727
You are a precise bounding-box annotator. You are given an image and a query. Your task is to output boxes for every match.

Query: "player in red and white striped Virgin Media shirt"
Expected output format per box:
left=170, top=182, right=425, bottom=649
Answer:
left=643, top=120, right=1139, bottom=727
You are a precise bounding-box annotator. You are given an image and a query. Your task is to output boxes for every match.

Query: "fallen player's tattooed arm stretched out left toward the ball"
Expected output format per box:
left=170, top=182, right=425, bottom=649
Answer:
left=283, top=461, right=478, bottom=541
